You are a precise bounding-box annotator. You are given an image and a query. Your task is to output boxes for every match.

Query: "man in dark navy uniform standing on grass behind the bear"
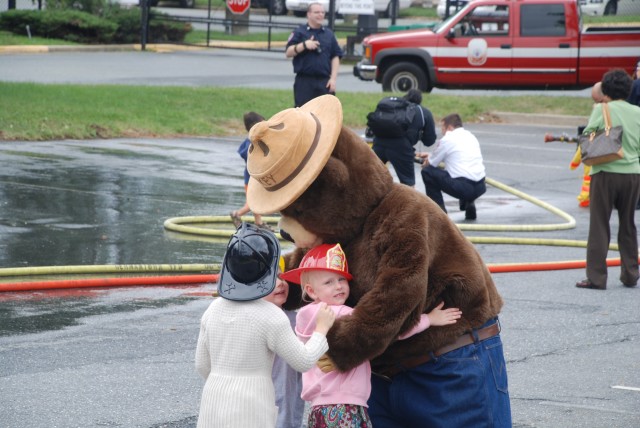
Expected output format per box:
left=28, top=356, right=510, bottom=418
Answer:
left=285, top=3, right=344, bottom=107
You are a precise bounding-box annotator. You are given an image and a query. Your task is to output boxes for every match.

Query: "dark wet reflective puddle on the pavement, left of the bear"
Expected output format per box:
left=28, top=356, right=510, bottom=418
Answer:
left=0, top=138, right=254, bottom=336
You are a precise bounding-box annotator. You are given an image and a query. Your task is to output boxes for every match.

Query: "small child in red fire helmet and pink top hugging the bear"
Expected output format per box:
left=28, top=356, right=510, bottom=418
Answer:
left=280, top=244, right=462, bottom=428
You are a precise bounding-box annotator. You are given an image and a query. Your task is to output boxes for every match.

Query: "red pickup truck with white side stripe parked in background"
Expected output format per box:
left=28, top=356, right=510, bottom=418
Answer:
left=353, top=0, right=640, bottom=92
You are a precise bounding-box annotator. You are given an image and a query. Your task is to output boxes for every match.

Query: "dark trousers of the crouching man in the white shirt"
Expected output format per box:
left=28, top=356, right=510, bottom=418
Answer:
left=422, top=165, right=487, bottom=212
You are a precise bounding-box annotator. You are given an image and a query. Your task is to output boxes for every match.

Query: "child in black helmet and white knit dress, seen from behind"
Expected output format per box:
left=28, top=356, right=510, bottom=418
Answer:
left=195, top=223, right=335, bottom=428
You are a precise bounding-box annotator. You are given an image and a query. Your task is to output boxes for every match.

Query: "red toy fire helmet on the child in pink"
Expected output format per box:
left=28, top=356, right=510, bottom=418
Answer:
left=280, top=244, right=353, bottom=284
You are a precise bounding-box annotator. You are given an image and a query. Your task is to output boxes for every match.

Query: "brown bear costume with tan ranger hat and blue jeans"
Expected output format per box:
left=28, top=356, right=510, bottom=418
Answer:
left=247, top=95, right=511, bottom=428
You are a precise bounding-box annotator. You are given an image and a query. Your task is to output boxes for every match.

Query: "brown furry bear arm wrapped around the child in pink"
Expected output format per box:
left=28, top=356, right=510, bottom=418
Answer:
left=327, top=210, right=430, bottom=371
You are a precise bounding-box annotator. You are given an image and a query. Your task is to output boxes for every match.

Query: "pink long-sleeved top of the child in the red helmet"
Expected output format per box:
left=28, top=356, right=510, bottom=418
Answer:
left=296, top=303, right=429, bottom=407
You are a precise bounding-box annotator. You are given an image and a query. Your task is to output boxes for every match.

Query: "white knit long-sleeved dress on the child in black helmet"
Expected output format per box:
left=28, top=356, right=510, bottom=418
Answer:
left=196, top=298, right=329, bottom=428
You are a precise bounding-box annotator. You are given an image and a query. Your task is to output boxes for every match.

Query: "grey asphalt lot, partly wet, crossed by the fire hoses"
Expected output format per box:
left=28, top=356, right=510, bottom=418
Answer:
left=0, top=49, right=640, bottom=428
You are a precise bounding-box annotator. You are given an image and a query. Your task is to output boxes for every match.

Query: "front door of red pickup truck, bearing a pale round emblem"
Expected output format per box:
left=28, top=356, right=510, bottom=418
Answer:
left=435, top=3, right=513, bottom=87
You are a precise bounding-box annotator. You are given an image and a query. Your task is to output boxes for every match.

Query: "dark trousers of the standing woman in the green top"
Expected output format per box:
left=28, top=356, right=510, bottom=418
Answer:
left=587, top=171, right=640, bottom=286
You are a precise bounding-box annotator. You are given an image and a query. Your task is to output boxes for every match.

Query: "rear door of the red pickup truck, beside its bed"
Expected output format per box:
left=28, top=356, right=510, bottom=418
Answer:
left=513, top=2, right=579, bottom=86
